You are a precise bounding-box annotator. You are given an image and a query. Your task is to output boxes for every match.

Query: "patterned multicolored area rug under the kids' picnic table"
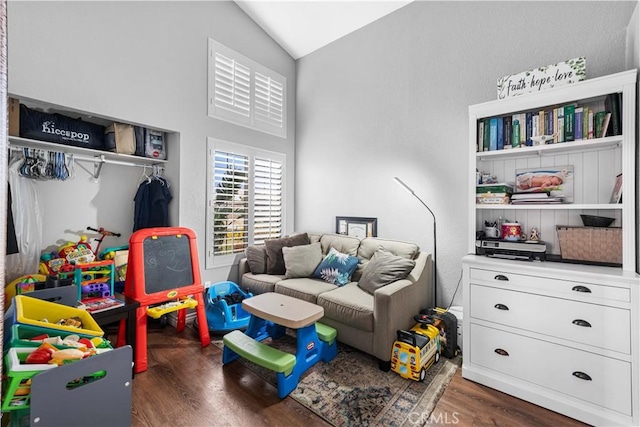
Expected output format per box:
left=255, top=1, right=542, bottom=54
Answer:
left=212, top=331, right=460, bottom=427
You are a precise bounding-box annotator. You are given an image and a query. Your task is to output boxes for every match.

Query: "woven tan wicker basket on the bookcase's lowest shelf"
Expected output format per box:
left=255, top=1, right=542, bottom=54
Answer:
left=556, top=225, right=622, bottom=264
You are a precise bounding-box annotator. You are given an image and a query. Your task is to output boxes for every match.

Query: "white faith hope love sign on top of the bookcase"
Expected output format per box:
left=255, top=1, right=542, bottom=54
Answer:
left=498, top=57, right=587, bottom=99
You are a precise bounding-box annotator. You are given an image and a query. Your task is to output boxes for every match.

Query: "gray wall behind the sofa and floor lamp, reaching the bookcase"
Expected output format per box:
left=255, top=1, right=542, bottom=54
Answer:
left=295, top=1, right=636, bottom=305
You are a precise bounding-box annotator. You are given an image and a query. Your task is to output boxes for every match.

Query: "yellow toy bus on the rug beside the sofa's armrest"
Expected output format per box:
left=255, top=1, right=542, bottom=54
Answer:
left=391, top=325, right=441, bottom=381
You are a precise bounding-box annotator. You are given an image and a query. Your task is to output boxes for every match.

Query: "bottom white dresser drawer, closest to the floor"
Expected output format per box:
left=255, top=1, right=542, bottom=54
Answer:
left=465, top=323, right=631, bottom=415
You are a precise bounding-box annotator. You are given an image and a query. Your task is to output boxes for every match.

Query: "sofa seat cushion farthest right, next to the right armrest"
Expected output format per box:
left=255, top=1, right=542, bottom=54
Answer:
left=316, top=282, right=376, bottom=334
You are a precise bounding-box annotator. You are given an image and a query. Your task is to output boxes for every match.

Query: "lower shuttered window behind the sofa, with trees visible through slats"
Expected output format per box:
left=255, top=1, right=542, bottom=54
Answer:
left=207, top=138, right=285, bottom=268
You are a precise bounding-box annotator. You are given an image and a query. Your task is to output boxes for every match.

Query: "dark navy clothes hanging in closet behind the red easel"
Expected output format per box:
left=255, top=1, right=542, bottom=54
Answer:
left=133, top=174, right=173, bottom=231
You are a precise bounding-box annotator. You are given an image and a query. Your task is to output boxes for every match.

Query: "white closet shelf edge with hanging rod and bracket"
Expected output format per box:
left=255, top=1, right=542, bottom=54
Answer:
left=9, top=136, right=167, bottom=179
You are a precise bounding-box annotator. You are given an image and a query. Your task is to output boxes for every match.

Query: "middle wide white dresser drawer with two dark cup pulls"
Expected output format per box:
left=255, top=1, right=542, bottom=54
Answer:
left=470, top=284, right=631, bottom=354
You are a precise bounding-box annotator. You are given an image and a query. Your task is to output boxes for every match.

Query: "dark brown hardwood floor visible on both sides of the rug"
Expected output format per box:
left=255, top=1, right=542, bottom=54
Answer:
left=126, top=326, right=583, bottom=427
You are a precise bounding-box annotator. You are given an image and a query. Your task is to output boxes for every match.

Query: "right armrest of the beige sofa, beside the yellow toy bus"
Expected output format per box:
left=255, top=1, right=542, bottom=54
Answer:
left=373, top=253, right=433, bottom=361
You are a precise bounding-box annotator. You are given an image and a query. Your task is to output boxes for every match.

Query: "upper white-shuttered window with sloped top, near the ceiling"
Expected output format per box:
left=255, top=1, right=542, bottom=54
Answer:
left=209, top=39, right=287, bottom=138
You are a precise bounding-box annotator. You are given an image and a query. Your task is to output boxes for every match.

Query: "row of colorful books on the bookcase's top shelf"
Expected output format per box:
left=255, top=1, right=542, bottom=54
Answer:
left=477, top=93, right=622, bottom=152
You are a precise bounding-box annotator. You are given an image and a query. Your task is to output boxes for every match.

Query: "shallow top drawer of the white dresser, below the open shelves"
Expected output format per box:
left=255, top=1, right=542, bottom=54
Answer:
left=469, top=268, right=631, bottom=302
